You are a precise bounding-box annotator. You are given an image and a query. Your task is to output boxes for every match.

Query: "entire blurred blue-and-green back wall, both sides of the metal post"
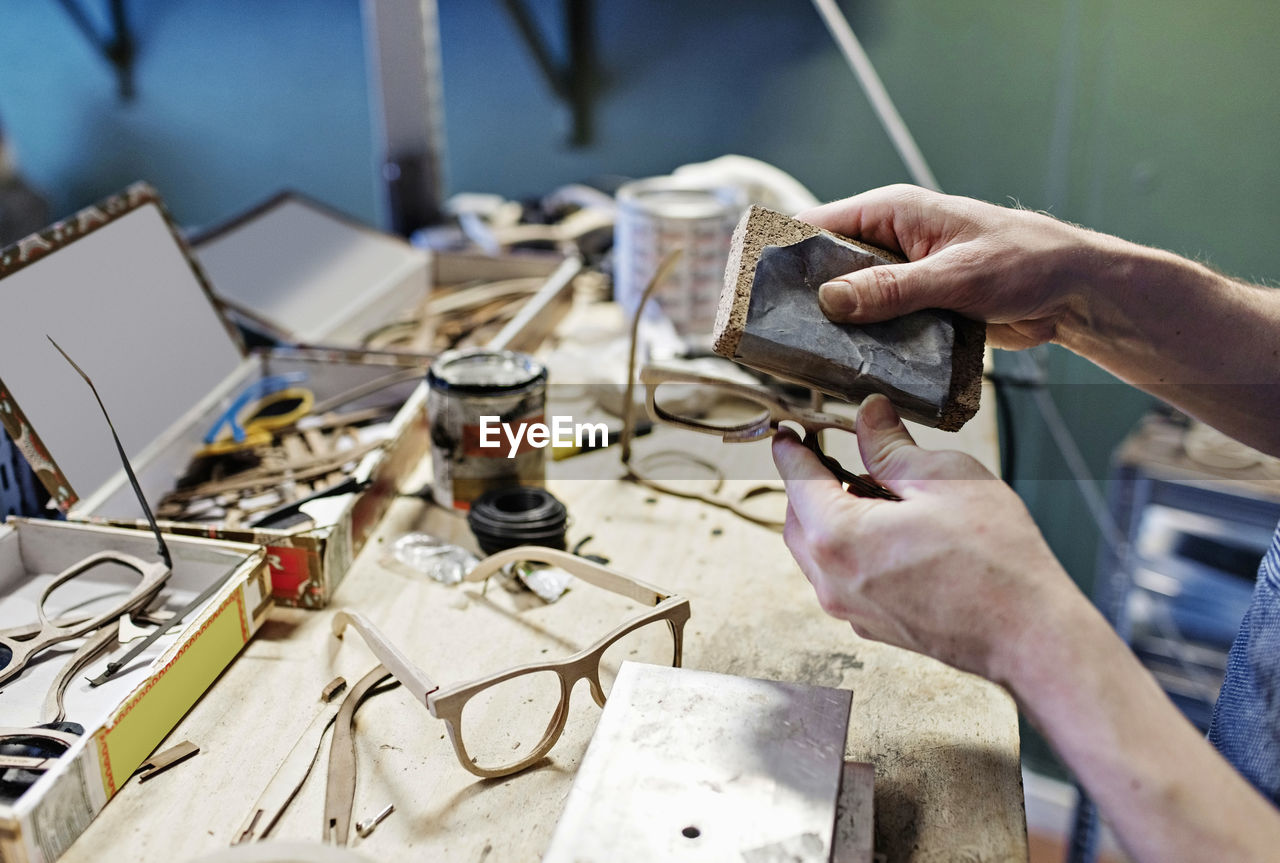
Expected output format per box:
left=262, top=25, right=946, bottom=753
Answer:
left=0, top=0, right=1280, bottom=583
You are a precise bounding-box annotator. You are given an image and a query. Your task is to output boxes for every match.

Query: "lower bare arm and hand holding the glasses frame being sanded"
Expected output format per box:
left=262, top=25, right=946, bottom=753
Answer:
left=774, top=396, right=1280, bottom=863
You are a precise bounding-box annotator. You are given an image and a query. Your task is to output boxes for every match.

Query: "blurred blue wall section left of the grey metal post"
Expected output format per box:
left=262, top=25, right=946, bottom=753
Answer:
left=0, top=0, right=375, bottom=224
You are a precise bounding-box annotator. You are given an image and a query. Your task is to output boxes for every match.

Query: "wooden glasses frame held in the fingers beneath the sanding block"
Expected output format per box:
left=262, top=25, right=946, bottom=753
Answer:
left=640, top=365, right=902, bottom=501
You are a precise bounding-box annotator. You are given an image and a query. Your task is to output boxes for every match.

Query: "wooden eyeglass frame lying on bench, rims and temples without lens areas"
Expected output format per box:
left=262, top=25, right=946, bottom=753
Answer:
left=333, top=545, right=690, bottom=778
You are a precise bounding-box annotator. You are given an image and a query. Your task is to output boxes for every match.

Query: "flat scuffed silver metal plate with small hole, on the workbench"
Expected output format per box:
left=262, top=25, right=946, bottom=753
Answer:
left=543, top=662, right=870, bottom=863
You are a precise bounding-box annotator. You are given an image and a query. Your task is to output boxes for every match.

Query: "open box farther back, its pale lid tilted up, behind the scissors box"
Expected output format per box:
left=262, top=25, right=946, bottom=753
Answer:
left=191, top=192, right=581, bottom=353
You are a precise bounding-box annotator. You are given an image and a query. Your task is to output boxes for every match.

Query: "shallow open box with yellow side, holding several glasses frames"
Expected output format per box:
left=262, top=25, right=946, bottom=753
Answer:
left=0, top=519, right=271, bottom=863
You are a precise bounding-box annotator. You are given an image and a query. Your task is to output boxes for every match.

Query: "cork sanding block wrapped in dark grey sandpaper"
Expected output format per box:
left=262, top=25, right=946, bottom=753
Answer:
left=714, top=206, right=987, bottom=432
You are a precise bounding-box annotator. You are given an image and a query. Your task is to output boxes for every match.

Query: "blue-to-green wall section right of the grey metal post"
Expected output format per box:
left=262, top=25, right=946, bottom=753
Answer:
left=442, top=0, right=1280, bottom=588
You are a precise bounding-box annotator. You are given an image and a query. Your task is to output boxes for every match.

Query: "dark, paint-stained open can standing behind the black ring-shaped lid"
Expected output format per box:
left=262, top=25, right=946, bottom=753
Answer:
left=426, top=348, right=547, bottom=510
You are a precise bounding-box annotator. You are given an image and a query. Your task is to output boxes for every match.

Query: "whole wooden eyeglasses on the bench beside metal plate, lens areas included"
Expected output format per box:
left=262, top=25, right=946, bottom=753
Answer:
left=333, top=547, right=689, bottom=778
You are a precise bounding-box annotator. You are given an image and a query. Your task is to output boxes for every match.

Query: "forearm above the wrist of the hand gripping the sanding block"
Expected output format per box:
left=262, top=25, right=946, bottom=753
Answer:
left=1055, top=234, right=1280, bottom=455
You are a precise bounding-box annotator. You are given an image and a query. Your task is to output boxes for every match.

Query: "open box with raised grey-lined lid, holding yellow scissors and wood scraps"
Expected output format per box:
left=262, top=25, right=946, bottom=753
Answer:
left=0, top=184, right=429, bottom=608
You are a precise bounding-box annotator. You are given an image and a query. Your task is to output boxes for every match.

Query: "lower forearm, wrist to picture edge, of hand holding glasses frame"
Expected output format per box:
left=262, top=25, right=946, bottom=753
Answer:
left=1009, top=594, right=1280, bottom=863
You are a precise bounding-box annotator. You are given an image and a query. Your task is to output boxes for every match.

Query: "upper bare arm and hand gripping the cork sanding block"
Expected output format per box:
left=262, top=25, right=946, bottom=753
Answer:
left=799, top=186, right=1280, bottom=455
